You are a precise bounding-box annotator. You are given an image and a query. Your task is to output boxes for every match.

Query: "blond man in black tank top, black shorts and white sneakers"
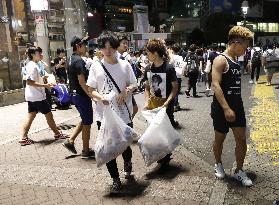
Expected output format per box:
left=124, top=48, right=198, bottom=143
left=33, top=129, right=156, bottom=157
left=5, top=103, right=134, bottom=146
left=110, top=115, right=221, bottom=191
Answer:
left=211, top=26, right=253, bottom=186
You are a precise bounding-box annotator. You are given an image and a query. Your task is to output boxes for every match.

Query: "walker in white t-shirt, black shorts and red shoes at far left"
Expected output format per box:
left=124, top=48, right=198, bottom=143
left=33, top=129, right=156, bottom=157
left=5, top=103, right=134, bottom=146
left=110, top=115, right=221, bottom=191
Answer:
left=19, top=48, right=67, bottom=146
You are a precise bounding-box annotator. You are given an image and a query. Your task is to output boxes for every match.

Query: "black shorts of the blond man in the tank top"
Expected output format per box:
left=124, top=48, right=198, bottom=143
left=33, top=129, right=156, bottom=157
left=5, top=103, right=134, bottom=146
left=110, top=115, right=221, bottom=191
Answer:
left=211, top=102, right=246, bottom=134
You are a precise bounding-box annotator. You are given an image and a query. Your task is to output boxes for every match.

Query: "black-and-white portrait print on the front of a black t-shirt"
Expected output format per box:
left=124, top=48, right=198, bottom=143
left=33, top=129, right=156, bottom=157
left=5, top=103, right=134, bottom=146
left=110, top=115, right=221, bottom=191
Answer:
left=147, top=72, right=167, bottom=98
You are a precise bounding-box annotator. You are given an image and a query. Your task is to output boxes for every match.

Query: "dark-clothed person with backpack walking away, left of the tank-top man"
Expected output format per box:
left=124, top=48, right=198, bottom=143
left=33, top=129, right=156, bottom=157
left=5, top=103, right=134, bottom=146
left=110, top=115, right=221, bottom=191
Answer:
left=185, top=44, right=199, bottom=97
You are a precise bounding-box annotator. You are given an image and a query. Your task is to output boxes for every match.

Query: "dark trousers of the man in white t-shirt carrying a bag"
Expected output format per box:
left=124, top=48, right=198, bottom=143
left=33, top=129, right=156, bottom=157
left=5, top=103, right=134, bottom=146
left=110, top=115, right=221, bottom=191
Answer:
left=97, top=121, right=133, bottom=179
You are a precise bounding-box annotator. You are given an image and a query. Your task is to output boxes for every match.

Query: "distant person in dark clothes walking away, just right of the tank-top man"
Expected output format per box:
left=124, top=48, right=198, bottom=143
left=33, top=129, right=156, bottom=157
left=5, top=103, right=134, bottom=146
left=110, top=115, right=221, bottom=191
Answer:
left=249, top=45, right=262, bottom=84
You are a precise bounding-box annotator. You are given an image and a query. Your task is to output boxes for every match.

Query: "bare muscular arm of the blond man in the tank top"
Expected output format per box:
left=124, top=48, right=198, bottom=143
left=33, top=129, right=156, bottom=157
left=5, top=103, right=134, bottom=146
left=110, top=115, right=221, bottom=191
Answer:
left=212, top=56, right=235, bottom=122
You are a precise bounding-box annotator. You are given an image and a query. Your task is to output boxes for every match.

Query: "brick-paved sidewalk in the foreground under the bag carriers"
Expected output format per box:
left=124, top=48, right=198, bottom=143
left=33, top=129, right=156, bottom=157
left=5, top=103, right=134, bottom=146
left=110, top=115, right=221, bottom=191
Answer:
left=0, top=113, right=222, bottom=205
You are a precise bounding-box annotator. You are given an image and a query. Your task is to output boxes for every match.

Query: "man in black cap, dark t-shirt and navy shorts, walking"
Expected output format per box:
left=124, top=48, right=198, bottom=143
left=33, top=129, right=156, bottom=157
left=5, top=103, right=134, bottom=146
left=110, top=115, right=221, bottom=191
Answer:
left=62, top=36, right=95, bottom=159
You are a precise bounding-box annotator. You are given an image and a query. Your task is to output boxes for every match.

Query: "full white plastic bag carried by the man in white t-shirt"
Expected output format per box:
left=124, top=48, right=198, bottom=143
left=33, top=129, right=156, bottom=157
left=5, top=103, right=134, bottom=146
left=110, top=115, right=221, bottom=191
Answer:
left=95, top=106, right=138, bottom=167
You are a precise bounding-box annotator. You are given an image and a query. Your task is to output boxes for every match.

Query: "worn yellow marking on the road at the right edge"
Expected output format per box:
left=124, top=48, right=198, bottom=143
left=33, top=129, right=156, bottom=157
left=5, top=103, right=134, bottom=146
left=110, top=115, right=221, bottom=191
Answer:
left=250, top=76, right=279, bottom=166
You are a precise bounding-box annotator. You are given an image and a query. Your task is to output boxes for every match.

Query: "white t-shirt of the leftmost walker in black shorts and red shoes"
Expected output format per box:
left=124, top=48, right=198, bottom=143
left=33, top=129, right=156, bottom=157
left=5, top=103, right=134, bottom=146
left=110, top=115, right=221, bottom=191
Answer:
left=25, top=61, right=46, bottom=102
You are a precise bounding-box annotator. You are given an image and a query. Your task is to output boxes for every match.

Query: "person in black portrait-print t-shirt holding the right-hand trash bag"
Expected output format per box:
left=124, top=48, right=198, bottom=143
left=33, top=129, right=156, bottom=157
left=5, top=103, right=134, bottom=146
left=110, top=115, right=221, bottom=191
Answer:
left=143, top=39, right=179, bottom=166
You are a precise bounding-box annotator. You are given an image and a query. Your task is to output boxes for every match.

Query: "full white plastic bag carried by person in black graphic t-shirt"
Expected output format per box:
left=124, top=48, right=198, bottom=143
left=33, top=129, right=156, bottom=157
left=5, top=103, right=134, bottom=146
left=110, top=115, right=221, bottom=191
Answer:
left=138, top=108, right=184, bottom=166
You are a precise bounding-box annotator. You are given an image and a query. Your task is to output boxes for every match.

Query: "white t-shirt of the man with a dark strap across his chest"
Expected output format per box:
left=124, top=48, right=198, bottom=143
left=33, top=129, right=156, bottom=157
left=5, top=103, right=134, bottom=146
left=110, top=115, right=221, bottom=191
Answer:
left=87, top=59, right=137, bottom=124
